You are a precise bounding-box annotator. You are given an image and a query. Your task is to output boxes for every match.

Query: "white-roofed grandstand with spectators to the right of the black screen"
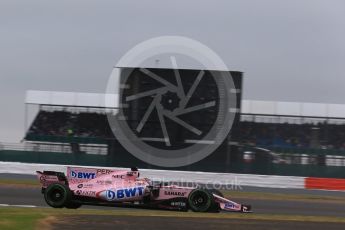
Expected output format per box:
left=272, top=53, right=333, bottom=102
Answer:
left=239, top=100, right=345, bottom=152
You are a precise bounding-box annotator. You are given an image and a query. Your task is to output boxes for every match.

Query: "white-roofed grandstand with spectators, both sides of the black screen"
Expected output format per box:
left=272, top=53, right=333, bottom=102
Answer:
left=25, top=91, right=345, bottom=151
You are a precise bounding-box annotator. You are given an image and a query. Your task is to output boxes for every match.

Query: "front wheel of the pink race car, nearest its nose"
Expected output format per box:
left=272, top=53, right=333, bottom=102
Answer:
left=188, top=189, right=215, bottom=212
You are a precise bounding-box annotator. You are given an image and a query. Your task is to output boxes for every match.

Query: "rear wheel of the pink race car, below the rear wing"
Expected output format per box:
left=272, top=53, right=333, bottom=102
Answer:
left=44, top=183, right=72, bottom=208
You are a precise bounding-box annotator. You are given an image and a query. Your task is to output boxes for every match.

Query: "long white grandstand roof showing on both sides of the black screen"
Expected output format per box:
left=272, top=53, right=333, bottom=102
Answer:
left=25, top=90, right=345, bottom=118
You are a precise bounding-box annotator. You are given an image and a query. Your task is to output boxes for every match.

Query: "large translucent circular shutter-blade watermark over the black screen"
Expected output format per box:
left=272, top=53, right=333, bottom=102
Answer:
left=106, top=36, right=237, bottom=167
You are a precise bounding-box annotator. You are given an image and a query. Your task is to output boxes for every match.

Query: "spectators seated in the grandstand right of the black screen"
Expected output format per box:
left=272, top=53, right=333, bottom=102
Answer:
left=237, top=122, right=345, bottom=150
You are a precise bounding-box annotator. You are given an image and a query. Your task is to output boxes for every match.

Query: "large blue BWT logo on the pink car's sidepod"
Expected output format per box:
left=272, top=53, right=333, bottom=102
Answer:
left=99, top=187, right=144, bottom=201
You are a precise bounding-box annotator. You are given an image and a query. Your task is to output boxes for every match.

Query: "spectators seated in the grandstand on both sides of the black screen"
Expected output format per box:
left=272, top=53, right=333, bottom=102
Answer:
left=28, top=111, right=345, bottom=149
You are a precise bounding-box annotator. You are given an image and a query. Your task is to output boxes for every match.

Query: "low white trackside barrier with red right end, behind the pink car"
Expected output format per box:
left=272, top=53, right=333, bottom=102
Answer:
left=0, top=162, right=345, bottom=191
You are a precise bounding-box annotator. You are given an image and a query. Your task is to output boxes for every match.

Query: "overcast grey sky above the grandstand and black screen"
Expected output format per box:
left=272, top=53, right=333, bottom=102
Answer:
left=0, top=0, right=345, bottom=142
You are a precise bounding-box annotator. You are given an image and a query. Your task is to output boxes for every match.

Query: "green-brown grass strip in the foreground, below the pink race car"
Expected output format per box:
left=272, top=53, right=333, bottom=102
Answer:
left=0, top=207, right=345, bottom=230
